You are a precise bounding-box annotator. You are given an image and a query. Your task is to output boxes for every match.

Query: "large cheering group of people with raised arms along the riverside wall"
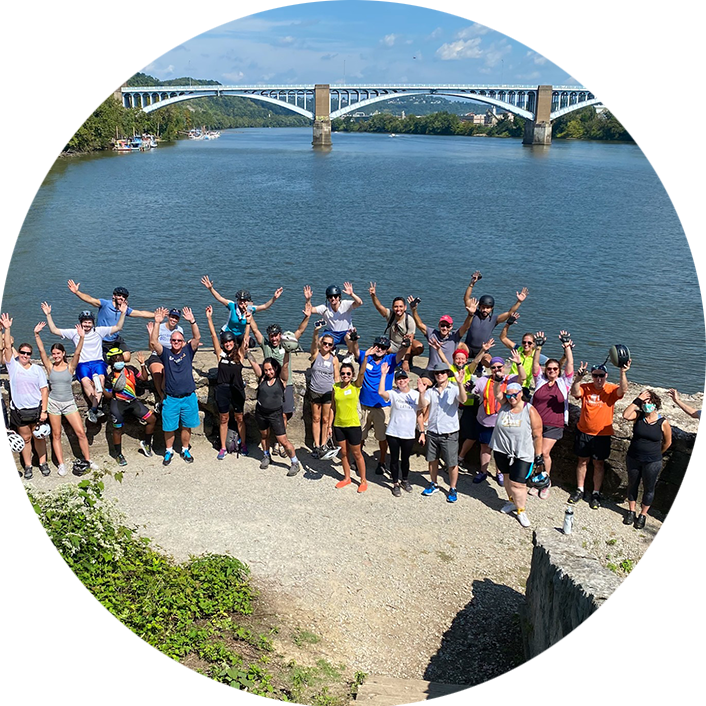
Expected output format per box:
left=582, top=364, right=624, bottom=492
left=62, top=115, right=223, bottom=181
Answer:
left=0, top=272, right=706, bottom=543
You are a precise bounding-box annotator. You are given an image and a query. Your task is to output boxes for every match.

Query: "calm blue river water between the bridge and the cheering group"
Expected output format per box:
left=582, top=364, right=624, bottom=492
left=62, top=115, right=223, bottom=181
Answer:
left=0, top=129, right=706, bottom=391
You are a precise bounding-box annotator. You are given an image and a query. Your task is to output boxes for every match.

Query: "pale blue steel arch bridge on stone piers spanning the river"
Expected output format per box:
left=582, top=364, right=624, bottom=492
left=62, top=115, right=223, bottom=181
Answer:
left=122, top=84, right=706, bottom=147
